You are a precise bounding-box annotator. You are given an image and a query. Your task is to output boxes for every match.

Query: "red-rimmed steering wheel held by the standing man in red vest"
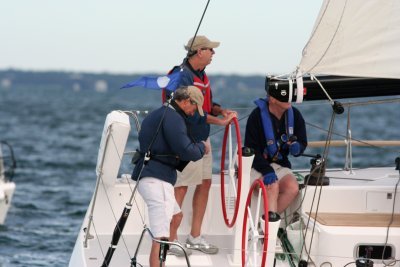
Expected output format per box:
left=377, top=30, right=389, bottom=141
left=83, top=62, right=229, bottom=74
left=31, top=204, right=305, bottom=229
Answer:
left=221, top=118, right=242, bottom=227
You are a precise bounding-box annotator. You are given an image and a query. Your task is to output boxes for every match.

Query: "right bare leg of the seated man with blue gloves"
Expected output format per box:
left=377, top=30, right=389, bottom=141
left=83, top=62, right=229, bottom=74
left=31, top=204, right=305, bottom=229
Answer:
left=277, top=174, right=299, bottom=213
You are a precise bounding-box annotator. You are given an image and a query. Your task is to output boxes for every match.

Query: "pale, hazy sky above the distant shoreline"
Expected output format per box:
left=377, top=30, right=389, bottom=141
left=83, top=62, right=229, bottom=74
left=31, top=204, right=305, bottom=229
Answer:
left=0, top=0, right=322, bottom=75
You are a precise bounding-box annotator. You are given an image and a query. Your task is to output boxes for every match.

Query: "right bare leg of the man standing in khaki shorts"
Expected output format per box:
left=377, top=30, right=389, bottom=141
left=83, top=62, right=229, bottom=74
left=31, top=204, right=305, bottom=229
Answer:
left=190, top=179, right=211, bottom=237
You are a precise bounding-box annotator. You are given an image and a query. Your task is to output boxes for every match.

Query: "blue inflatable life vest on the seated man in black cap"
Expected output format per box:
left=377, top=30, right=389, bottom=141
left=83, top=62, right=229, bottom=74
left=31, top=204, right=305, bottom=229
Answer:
left=254, top=98, right=294, bottom=161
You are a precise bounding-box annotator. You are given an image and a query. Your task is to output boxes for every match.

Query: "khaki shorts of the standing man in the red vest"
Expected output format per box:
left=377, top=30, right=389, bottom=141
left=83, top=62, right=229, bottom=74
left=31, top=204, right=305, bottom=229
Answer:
left=175, top=138, right=212, bottom=187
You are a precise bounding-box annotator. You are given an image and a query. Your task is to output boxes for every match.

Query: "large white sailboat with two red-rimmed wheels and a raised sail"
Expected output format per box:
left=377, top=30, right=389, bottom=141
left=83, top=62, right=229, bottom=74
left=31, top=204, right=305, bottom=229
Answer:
left=69, top=0, right=400, bottom=267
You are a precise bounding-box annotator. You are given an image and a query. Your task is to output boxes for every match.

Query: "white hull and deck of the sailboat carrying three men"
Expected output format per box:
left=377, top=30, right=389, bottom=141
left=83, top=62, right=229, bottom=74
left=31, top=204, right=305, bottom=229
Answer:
left=69, top=113, right=400, bottom=267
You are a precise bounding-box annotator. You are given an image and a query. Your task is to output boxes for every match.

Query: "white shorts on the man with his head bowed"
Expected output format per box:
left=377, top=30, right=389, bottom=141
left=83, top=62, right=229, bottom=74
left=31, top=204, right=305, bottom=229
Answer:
left=137, top=177, right=181, bottom=237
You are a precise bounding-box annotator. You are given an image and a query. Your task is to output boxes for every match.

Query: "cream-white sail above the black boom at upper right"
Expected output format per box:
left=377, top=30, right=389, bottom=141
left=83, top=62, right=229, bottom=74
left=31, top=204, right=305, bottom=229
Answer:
left=299, top=0, right=400, bottom=79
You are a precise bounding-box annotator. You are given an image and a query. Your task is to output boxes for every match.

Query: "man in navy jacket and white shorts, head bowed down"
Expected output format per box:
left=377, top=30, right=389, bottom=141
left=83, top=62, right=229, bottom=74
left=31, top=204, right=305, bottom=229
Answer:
left=132, top=86, right=210, bottom=267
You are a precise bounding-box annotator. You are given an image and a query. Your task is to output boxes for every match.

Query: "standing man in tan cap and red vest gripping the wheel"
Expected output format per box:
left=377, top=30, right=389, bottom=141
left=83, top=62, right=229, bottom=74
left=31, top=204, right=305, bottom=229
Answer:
left=163, top=35, right=237, bottom=256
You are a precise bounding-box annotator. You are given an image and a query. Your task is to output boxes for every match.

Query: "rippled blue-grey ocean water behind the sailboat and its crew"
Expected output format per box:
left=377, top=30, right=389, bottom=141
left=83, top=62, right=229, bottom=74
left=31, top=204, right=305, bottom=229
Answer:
left=0, top=82, right=400, bottom=267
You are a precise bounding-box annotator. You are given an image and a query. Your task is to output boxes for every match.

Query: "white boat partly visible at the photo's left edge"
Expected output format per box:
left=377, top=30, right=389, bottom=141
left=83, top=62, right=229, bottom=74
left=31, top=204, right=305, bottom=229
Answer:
left=0, top=141, right=16, bottom=225
